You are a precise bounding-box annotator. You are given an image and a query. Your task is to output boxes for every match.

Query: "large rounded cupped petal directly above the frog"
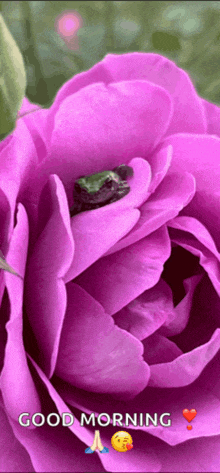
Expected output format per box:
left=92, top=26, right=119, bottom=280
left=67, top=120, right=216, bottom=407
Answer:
left=41, top=80, right=172, bottom=204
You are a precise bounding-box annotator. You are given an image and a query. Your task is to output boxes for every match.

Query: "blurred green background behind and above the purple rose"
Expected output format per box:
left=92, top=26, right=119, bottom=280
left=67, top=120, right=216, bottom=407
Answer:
left=0, top=0, right=220, bottom=106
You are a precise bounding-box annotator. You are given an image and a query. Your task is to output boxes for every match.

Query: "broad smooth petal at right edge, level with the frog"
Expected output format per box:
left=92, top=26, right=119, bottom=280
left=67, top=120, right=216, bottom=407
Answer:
left=156, top=134, right=220, bottom=250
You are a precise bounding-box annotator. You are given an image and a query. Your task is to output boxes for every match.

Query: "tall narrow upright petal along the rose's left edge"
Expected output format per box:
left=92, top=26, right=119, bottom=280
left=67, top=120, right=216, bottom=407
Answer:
left=1, top=204, right=41, bottom=420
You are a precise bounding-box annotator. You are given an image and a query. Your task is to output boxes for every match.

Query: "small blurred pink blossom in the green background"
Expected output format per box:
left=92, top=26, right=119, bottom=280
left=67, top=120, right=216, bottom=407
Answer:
left=55, top=10, right=83, bottom=50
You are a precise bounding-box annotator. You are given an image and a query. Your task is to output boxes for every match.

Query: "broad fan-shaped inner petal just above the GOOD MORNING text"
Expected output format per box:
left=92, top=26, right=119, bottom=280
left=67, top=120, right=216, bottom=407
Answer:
left=55, top=282, right=150, bottom=398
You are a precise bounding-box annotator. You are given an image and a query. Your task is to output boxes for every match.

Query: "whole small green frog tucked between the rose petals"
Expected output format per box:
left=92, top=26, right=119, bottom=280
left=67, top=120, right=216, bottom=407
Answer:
left=70, top=164, right=133, bottom=217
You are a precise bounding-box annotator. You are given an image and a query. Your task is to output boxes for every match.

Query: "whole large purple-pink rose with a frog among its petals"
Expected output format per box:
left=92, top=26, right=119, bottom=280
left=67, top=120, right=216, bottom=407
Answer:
left=0, top=53, right=220, bottom=472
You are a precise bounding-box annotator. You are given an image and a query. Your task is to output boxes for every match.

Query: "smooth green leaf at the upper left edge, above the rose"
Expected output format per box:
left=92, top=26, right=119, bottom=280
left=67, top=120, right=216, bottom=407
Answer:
left=0, top=14, right=26, bottom=138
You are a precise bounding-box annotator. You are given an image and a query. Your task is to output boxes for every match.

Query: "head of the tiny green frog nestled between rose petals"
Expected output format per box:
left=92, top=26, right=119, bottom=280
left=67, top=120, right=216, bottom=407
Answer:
left=74, top=171, right=120, bottom=204
